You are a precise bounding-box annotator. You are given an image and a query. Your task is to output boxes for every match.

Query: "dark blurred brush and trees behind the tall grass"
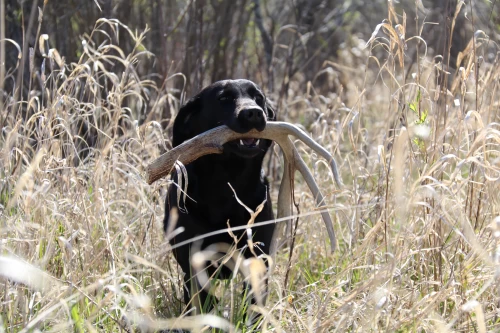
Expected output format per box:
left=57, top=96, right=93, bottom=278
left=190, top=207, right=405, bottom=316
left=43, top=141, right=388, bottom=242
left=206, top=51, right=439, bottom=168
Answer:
left=5, top=0, right=500, bottom=122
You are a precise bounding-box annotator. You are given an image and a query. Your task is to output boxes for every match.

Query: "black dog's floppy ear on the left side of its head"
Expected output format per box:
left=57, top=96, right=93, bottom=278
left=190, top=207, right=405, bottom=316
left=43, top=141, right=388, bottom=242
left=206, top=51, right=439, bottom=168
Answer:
left=172, top=96, right=201, bottom=147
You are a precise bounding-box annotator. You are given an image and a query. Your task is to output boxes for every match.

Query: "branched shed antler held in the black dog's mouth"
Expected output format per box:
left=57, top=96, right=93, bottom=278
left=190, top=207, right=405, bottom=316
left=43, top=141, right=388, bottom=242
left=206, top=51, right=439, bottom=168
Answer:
left=146, top=121, right=342, bottom=253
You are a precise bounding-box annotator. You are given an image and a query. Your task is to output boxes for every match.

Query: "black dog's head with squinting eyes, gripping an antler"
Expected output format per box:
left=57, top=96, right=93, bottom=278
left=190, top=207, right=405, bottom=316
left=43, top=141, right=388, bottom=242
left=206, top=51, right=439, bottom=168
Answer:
left=172, top=80, right=275, bottom=158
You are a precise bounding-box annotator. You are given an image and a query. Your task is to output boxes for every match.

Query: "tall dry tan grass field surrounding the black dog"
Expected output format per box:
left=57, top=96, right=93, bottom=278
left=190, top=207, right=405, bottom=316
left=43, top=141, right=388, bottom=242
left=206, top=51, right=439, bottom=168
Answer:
left=0, top=2, right=500, bottom=333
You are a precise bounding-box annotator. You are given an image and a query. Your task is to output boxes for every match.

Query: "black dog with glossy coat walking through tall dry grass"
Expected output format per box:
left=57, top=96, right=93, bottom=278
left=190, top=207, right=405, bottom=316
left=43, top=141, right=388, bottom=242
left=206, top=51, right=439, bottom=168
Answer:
left=164, top=80, right=275, bottom=312
